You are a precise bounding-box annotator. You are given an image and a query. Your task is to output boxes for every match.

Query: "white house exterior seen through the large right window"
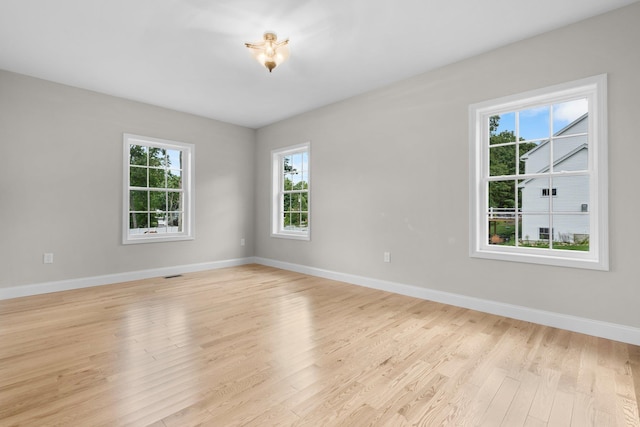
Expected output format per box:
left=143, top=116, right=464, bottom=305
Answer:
left=520, top=114, right=589, bottom=243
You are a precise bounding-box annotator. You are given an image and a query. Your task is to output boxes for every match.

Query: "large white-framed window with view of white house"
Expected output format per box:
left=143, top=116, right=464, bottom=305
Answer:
left=469, top=75, right=609, bottom=270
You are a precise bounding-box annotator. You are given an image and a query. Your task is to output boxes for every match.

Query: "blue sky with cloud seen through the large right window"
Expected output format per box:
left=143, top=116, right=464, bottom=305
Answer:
left=496, top=98, right=588, bottom=140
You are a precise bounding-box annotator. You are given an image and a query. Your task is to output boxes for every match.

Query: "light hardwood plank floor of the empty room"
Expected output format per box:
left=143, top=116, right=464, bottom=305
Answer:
left=0, top=265, right=640, bottom=427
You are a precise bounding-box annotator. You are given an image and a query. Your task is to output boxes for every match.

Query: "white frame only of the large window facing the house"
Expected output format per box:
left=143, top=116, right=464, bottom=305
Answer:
left=469, top=74, right=609, bottom=271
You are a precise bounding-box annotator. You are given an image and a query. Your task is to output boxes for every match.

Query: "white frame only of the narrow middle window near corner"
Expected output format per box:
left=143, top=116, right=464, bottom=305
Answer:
left=271, top=142, right=312, bottom=241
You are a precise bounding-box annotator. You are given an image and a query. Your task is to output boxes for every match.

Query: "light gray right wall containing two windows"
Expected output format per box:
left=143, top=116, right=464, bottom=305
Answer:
left=256, top=3, right=640, bottom=327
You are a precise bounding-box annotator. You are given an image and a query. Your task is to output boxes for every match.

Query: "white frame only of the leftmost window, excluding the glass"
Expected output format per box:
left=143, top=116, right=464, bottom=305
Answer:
left=122, top=133, right=195, bottom=245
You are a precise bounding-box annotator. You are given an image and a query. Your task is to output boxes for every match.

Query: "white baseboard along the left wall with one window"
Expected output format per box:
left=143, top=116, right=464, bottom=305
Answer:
left=0, top=257, right=255, bottom=300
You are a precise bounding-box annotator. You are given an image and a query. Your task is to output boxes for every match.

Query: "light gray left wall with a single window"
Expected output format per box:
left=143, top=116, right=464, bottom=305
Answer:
left=0, top=71, right=255, bottom=288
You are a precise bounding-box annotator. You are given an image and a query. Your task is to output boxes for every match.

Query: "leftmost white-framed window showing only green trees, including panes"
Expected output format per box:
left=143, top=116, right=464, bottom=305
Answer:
left=122, top=134, right=195, bottom=244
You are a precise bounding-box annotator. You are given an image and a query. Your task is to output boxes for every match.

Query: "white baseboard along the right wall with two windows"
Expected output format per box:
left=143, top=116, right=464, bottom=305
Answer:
left=254, top=257, right=640, bottom=345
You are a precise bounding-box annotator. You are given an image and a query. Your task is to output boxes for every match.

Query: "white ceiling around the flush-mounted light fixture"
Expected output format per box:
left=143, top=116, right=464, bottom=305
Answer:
left=0, top=0, right=637, bottom=128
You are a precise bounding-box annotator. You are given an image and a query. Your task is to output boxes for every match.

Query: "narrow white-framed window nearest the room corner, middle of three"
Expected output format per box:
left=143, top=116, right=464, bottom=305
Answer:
left=271, top=142, right=311, bottom=240
